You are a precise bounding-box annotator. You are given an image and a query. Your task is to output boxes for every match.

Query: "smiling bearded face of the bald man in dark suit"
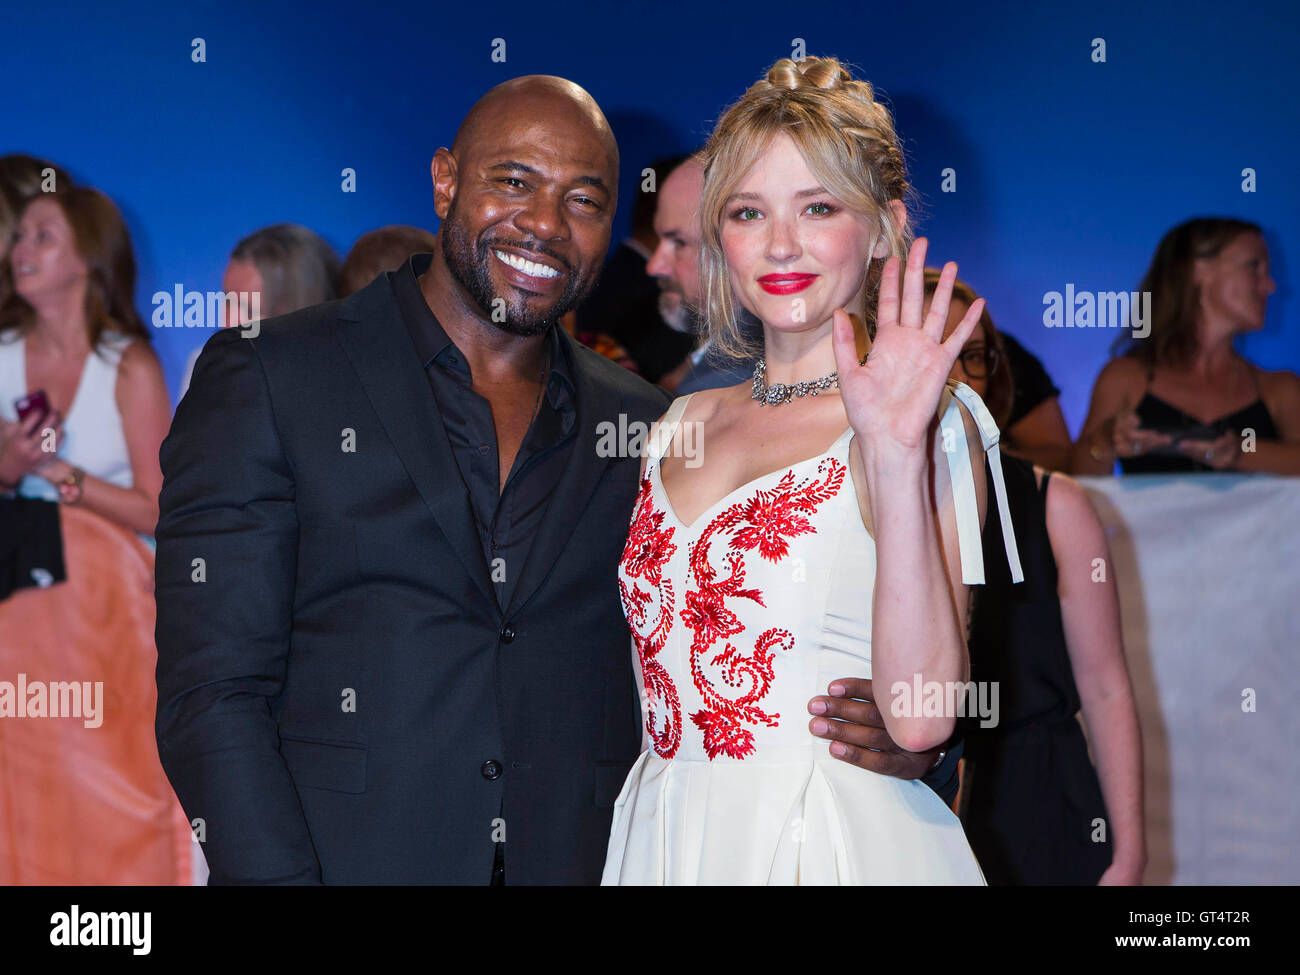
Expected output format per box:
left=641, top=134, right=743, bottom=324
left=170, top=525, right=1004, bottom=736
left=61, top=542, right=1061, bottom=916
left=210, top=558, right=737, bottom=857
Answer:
left=439, top=92, right=618, bottom=335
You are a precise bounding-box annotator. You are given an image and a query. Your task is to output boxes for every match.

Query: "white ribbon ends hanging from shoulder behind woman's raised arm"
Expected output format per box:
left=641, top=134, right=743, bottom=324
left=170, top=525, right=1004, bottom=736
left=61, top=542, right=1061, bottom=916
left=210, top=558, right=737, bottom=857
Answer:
left=940, top=381, right=1024, bottom=585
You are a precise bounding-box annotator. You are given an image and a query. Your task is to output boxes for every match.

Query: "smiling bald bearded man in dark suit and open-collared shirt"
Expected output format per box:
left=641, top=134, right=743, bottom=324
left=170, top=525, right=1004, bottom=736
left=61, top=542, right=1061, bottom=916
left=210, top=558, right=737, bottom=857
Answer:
left=156, top=75, right=946, bottom=884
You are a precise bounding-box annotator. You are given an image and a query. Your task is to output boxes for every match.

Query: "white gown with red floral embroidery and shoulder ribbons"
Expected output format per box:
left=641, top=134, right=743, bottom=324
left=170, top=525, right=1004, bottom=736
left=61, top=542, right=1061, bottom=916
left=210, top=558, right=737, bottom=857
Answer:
left=602, top=384, right=1021, bottom=884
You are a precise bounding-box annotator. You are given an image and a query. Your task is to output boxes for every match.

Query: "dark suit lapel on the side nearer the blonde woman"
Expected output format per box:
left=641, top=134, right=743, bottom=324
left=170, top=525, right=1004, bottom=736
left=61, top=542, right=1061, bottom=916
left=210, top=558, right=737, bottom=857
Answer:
left=506, top=332, right=623, bottom=619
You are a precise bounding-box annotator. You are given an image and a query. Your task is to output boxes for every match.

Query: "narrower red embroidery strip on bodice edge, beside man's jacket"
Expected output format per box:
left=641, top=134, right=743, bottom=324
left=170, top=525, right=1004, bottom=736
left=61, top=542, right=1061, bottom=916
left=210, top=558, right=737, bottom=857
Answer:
left=619, top=476, right=681, bottom=758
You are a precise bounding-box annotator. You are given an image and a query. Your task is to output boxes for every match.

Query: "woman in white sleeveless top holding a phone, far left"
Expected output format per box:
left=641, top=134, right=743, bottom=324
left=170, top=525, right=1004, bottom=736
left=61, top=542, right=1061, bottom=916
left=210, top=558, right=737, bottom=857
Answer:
left=0, top=187, right=172, bottom=536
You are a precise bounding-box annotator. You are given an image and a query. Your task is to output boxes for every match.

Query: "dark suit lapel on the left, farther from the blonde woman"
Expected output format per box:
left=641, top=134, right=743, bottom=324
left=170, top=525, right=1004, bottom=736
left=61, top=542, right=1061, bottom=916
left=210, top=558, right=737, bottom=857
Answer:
left=339, top=276, right=498, bottom=608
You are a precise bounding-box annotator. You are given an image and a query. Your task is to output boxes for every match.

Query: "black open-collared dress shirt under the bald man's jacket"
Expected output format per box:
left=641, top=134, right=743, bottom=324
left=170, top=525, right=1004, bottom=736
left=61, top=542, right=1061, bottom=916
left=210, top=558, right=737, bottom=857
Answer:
left=387, top=254, right=577, bottom=611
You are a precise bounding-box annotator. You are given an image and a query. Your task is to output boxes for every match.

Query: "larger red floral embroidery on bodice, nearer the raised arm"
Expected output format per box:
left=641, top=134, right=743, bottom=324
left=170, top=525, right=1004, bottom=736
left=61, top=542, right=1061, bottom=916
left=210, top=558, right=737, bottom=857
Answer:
left=675, top=458, right=848, bottom=759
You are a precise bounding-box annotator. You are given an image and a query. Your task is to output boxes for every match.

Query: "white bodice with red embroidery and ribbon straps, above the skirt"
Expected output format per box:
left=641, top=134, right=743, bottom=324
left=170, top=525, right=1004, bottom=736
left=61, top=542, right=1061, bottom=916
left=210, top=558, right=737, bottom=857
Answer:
left=619, top=382, right=1021, bottom=761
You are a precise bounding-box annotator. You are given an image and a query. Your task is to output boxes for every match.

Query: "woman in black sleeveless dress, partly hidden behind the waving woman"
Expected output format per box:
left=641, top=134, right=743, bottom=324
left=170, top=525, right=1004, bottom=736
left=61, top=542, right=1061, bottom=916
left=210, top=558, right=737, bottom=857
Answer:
left=926, top=272, right=1145, bottom=884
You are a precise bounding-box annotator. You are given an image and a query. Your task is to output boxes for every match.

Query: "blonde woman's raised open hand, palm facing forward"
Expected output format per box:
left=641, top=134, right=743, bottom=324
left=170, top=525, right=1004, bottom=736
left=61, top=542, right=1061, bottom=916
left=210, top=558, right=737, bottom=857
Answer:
left=832, top=238, right=984, bottom=452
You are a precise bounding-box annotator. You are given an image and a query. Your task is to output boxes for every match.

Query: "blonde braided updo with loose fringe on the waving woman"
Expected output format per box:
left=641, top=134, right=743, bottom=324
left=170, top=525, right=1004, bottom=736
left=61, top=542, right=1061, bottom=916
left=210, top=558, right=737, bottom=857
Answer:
left=699, top=57, right=913, bottom=359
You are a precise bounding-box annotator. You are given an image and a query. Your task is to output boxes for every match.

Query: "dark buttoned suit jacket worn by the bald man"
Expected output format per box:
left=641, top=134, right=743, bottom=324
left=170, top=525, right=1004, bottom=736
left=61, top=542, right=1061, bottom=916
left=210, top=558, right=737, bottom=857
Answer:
left=156, top=276, right=668, bottom=884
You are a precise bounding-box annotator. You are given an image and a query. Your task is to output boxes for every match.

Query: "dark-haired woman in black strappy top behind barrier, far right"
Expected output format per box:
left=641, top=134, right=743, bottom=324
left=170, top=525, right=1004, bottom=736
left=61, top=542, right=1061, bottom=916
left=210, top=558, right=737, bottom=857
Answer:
left=1071, top=217, right=1300, bottom=475
